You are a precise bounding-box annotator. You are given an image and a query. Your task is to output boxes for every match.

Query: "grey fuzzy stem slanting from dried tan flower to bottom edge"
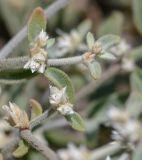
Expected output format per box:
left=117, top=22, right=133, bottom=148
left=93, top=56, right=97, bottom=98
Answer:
left=20, top=129, right=58, bottom=160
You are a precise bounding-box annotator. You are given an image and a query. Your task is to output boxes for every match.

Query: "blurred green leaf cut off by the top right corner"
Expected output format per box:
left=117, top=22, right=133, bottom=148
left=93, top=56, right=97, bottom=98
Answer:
left=132, top=0, right=142, bottom=33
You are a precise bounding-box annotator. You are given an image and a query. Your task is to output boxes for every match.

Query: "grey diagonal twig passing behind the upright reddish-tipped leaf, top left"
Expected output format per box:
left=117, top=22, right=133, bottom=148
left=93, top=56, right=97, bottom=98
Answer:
left=0, top=0, right=70, bottom=58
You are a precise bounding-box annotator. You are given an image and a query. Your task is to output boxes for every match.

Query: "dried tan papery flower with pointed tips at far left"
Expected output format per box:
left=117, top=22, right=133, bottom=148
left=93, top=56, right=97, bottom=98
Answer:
left=3, top=102, right=29, bottom=129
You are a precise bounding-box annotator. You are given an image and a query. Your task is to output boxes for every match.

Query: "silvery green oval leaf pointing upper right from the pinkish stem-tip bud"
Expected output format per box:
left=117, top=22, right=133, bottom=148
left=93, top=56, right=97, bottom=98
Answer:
left=97, top=34, right=120, bottom=50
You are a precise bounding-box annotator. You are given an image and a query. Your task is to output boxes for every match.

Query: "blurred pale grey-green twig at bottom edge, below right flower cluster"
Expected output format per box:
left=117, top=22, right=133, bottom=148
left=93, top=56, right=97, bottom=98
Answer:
left=91, top=142, right=124, bottom=160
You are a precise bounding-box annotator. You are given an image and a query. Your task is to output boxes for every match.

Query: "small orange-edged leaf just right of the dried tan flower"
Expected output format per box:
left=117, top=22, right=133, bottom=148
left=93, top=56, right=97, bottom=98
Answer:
left=30, top=99, right=43, bottom=120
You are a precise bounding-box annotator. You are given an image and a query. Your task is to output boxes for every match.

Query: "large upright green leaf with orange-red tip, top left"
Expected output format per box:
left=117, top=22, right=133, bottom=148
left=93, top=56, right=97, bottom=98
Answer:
left=28, top=7, right=46, bottom=42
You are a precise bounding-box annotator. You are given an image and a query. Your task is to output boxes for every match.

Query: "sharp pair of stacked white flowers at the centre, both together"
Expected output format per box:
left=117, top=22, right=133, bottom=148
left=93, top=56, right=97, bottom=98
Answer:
left=49, top=86, right=74, bottom=116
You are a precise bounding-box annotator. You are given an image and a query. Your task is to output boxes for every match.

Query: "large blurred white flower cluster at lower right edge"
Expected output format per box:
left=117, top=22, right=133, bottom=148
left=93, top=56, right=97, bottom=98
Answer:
left=108, top=108, right=142, bottom=145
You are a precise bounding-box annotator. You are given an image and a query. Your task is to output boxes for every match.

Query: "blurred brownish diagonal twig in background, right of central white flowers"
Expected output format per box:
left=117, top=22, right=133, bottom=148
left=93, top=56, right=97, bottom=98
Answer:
left=76, top=64, right=121, bottom=100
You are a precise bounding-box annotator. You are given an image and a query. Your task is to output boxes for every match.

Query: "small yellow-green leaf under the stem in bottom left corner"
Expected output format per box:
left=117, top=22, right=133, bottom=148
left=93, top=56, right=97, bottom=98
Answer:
left=13, top=140, right=29, bottom=158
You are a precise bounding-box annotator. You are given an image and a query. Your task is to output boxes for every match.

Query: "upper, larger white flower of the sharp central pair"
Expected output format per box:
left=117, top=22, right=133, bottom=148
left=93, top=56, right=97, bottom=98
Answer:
left=49, top=86, right=67, bottom=106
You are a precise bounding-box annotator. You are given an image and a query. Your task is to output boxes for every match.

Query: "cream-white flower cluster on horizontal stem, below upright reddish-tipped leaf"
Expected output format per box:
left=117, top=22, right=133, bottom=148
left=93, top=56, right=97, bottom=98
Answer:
left=24, top=30, right=49, bottom=73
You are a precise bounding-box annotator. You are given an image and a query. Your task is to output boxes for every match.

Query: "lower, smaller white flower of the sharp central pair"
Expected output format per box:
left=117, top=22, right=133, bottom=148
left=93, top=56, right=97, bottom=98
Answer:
left=57, top=103, right=74, bottom=115
